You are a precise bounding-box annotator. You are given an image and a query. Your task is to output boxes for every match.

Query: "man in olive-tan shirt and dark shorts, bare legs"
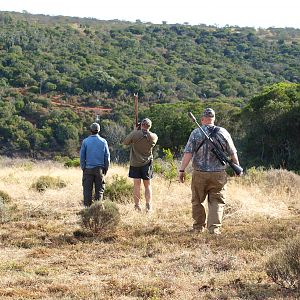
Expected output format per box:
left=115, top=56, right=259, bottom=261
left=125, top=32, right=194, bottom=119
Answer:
left=123, top=118, right=158, bottom=212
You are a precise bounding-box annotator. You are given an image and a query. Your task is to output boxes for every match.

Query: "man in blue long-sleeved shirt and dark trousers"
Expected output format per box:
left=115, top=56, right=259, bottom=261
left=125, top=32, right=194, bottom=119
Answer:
left=80, top=123, right=110, bottom=206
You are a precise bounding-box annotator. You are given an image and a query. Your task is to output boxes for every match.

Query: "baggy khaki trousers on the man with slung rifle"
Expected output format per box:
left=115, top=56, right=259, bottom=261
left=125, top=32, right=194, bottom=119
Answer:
left=191, top=170, right=227, bottom=231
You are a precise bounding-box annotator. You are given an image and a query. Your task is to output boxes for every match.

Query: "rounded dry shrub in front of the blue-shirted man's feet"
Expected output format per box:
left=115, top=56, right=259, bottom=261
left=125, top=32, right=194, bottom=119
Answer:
left=79, top=201, right=120, bottom=234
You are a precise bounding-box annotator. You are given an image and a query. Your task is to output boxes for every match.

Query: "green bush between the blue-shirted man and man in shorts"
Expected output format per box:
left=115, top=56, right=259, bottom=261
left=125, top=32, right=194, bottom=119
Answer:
left=104, top=175, right=133, bottom=203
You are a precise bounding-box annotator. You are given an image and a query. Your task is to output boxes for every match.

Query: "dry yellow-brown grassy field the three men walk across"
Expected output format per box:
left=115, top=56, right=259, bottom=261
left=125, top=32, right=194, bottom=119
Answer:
left=0, top=157, right=300, bottom=300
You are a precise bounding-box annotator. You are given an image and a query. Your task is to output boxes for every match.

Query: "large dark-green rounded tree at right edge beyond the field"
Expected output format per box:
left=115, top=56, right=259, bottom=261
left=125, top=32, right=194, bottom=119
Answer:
left=242, top=83, right=300, bottom=170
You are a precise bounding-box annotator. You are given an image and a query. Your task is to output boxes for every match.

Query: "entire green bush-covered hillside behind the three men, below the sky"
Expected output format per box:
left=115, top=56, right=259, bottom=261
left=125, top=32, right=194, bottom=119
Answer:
left=0, top=12, right=300, bottom=171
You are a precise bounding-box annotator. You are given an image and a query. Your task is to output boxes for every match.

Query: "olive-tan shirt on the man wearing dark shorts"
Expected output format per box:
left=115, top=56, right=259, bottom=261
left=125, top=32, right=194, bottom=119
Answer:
left=123, top=129, right=158, bottom=167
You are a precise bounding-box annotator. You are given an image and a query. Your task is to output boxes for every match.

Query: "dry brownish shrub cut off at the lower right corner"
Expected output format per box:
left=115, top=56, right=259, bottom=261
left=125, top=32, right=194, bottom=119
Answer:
left=266, top=237, right=300, bottom=290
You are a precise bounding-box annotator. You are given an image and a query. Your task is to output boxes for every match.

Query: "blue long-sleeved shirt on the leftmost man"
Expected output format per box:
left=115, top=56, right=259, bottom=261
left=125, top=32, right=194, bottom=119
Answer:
left=80, top=134, right=110, bottom=170
